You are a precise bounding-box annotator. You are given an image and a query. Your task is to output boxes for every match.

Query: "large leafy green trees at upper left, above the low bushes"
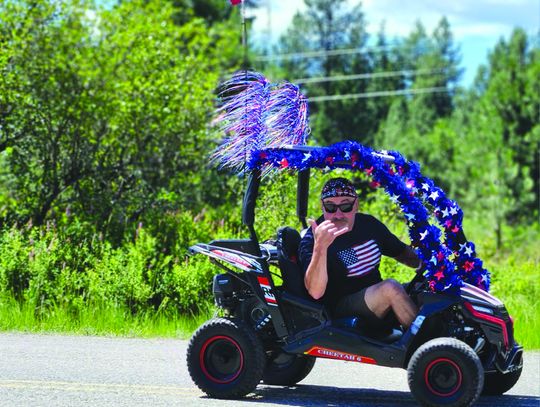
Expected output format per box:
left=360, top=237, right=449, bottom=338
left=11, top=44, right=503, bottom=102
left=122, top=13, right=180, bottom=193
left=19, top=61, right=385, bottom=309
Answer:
left=0, top=0, right=238, bottom=240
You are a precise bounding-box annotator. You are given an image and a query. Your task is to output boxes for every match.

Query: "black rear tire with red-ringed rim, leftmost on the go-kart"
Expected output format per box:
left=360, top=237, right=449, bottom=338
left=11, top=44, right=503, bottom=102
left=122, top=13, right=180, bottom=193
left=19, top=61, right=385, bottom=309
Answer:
left=187, top=318, right=266, bottom=399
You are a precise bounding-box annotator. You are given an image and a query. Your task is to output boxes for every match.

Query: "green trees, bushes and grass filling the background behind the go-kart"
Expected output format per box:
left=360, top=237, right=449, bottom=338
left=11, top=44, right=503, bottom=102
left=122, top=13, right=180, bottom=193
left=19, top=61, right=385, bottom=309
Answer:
left=0, top=0, right=540, bottom=348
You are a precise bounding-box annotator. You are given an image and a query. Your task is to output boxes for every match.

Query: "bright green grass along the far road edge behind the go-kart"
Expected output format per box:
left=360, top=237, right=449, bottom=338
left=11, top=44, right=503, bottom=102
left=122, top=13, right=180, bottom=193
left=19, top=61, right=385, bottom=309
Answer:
left=0, top=268, right=540, bottom=350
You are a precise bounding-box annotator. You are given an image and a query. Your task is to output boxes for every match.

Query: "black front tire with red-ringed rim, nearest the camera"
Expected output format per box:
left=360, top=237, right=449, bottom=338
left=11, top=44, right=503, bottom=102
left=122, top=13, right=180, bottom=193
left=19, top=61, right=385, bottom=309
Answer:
left=407, top=338, right=484, bottom=407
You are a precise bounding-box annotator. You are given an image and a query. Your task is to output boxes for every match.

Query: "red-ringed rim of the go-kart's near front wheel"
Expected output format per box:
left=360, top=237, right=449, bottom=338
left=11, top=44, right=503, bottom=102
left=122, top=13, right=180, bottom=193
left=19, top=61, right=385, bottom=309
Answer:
left=424, top=358, right=463, bottom=397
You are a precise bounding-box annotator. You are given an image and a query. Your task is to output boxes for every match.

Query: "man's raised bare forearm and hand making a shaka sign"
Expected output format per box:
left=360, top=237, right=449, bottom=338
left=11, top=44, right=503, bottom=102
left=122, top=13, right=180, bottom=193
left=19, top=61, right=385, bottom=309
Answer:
left=304, top=219, right=348, bottom=300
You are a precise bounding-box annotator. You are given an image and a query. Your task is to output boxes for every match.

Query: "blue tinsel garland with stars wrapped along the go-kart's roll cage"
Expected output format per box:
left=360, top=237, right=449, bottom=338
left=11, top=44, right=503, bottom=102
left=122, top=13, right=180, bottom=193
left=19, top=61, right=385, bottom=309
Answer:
left=247, top=141, right=490, bottom=291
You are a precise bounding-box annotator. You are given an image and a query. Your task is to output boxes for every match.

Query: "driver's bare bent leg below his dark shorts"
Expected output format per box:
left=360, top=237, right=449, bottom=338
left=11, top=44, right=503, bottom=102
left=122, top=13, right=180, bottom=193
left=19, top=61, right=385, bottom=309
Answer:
left=364, top=279, right=418, bottom=328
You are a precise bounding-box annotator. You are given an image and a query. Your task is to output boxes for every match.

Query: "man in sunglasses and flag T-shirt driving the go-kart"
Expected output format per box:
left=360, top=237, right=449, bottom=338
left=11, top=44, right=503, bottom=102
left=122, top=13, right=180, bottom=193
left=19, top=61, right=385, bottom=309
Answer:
left=300, top=178, right=420, bottom=328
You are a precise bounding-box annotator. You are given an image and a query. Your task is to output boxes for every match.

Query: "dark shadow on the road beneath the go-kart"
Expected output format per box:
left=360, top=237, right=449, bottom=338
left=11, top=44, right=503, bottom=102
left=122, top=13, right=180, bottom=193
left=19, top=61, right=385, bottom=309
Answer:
left=230, top=385, right=540, bottom=407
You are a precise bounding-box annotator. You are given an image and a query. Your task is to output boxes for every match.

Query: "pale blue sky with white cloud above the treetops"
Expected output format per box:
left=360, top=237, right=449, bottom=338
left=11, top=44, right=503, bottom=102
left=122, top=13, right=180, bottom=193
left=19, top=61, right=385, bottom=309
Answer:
left=249, top=0, right=540, bottom=86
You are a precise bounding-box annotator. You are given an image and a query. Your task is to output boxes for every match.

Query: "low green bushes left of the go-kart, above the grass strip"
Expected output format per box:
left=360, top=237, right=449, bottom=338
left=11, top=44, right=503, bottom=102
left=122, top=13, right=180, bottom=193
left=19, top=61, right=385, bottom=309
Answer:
left=0, top=206, right=242, bottom=314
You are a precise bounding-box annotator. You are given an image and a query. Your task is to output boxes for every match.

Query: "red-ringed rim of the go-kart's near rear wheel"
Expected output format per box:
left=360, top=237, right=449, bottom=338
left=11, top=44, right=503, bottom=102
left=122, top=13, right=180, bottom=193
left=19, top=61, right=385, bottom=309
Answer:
left=199, top=335, right=244, bottom=384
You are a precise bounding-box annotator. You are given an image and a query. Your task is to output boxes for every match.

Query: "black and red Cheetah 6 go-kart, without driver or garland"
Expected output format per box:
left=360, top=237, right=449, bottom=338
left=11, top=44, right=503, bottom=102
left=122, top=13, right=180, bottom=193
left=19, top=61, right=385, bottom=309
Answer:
left=187, top=146, right=523, bottom=406
